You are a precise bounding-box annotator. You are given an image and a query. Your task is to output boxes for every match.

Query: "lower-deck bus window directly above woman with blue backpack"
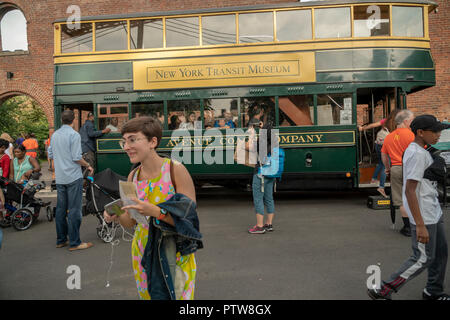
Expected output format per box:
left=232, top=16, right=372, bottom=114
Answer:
left=241, top=97, right=275, bottom=128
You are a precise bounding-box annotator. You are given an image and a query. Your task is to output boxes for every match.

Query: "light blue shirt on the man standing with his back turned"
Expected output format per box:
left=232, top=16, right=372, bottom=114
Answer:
left=48, top=125, right=83, bottom=184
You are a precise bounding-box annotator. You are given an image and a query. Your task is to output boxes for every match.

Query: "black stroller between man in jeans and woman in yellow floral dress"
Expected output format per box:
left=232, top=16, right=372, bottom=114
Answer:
left=83, top=168, right=127, bottom=243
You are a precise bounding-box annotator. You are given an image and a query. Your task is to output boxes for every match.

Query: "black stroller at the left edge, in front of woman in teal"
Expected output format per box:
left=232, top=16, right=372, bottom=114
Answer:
left=0, top=172, right=52, bottom=231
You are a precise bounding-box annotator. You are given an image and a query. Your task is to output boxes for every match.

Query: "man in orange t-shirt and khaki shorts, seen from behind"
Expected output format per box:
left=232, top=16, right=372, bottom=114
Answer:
left=381, top=110, right=415, bottom=237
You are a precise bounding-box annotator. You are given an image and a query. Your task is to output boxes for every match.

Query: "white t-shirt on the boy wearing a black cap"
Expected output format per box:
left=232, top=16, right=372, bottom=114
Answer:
left=402, top=142, right=442, bottom=225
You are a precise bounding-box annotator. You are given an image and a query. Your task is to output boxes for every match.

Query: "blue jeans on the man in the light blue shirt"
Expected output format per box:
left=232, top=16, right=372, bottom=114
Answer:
left=55, top=179, right=83, bottom=247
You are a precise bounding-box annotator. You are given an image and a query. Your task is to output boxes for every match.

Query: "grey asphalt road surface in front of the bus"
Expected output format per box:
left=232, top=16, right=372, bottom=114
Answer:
left=0, top=189, right=450, bottom=300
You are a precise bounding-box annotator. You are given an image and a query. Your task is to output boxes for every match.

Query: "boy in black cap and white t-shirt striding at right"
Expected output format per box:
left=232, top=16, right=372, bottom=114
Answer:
left=368, top=115, right=450, bottom=300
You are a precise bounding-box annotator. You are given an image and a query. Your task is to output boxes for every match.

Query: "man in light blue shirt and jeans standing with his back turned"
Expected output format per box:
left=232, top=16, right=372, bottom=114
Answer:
left=48, top=110, right=94, bottom=251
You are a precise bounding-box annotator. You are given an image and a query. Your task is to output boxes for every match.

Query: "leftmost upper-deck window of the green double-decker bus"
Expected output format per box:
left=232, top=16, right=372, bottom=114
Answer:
left=61, top=23, right=92, bottom=53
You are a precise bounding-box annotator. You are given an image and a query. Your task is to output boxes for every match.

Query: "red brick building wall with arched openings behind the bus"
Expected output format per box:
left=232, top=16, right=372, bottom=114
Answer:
left=0, top=0, right=450, bottom=127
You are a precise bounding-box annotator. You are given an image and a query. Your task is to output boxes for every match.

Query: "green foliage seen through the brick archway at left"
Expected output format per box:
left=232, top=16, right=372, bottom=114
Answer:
left=0, top=96, right=48, bottom=154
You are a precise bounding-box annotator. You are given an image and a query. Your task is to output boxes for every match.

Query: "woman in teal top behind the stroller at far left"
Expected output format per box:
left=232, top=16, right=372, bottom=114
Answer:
left=10, top=145, right=41, bottom=183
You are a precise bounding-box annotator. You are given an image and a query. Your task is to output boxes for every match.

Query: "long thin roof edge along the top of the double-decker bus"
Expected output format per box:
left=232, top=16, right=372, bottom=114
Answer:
left=55, top=0, right=438, bottom=23
